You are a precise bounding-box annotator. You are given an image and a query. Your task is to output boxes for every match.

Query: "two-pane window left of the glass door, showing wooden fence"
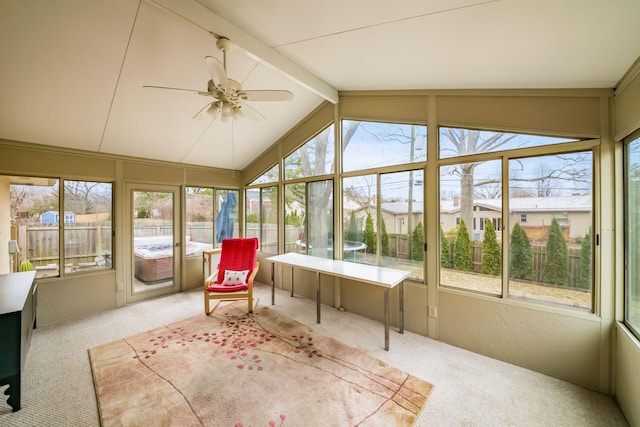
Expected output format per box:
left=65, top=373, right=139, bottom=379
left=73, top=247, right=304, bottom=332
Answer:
left=9, top=177, right=113, bottom=277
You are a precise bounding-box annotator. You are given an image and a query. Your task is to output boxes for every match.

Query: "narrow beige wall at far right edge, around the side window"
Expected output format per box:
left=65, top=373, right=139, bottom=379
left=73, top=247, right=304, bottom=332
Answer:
left=614, top=58, right=640, bottom=425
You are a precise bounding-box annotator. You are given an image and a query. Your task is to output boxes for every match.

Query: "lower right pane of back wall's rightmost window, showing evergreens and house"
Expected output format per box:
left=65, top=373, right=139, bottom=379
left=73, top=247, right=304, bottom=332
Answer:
left=509, top=151, right=594, bottom=309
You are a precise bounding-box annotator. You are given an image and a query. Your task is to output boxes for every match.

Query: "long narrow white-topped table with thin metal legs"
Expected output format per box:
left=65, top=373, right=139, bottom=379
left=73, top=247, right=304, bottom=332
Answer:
left=267, top=253, right=409, bottom=350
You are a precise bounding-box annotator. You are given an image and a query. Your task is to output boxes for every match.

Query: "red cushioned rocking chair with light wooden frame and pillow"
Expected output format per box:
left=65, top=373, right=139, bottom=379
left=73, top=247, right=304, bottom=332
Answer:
left=204, top=237, right=258, bottom=314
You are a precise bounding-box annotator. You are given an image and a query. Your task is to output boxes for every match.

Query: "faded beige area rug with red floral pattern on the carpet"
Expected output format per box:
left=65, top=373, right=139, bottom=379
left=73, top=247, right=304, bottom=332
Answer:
left=89, top=303, right=433, bottom=427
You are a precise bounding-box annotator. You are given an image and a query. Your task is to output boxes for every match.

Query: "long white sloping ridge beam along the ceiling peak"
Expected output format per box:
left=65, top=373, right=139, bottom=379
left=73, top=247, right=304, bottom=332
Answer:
left=149, top=0, right=338, bottom=104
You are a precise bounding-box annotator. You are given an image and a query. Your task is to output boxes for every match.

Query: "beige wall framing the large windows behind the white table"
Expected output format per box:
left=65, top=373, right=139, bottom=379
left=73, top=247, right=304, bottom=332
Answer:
left=252, top=89, right=614, bottom=394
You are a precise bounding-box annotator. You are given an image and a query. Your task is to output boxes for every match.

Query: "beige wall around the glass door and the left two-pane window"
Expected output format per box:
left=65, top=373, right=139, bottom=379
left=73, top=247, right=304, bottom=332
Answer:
left=0, top=140, right=239, bottom=325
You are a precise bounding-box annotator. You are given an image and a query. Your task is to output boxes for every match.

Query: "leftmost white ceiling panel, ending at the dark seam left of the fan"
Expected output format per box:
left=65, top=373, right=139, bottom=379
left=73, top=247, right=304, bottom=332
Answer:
left=0, top=0, right=137, bottom=151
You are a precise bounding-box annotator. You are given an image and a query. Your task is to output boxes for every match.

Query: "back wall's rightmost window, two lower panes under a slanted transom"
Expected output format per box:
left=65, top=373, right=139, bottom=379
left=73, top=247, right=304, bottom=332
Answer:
left=440, top=129, right=594, bottom=309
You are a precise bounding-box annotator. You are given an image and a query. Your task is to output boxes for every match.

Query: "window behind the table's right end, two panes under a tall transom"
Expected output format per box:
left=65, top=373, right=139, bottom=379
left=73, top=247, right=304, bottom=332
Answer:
left=342, top=120, right=427, bottom=280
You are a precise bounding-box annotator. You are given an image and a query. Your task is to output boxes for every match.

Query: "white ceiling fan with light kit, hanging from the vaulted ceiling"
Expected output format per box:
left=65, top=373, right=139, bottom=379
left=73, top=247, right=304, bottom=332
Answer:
left=143, top=37, right=293, bottom=122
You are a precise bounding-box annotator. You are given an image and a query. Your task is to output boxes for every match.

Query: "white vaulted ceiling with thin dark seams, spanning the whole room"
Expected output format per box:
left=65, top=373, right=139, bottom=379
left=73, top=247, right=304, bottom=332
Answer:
left=0, top=0, right=640, bottom=169
